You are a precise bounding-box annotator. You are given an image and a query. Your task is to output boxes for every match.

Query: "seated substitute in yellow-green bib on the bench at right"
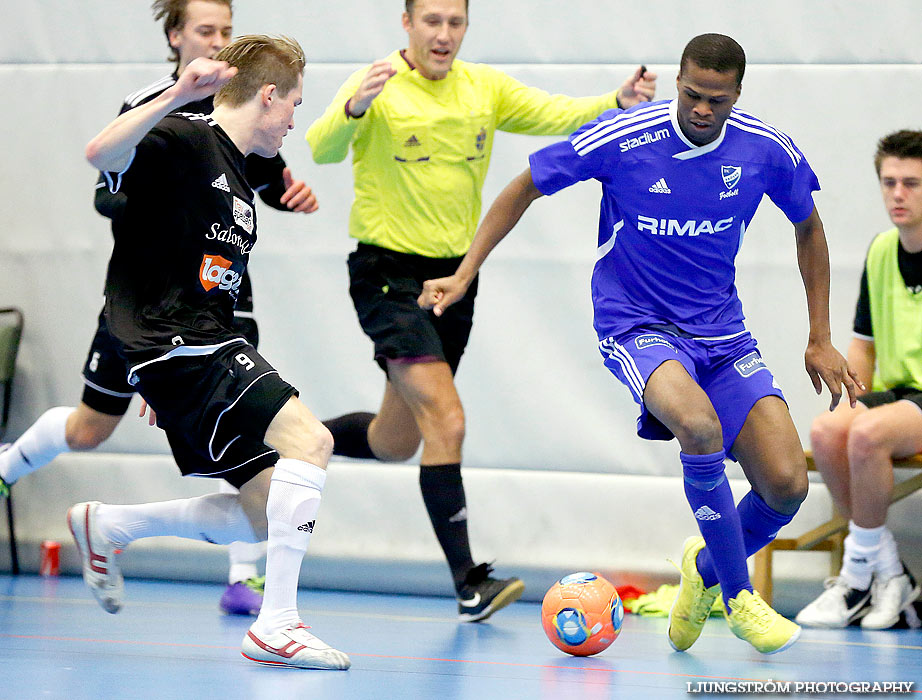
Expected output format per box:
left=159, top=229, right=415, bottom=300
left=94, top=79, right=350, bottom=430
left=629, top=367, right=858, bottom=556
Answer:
left=797, top=131, right=922, bottom=629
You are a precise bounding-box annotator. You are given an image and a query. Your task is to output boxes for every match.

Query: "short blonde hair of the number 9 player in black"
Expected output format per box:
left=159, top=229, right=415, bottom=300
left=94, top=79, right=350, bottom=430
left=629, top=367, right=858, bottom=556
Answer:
left=214, top=34, right=307, bottom=107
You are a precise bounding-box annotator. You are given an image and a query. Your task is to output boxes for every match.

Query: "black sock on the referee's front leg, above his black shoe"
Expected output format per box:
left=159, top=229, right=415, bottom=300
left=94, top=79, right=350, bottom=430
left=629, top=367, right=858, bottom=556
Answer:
left=419, top=463, right=474, bottom=590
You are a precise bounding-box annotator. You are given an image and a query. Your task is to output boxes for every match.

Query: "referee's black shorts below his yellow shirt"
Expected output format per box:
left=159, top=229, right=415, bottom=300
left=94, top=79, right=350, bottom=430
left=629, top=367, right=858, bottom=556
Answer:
left=349, top=243, right=478, bottom=374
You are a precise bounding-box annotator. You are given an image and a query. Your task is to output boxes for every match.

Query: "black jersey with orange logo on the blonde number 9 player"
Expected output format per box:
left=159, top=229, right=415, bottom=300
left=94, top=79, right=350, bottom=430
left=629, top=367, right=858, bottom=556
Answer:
left=106, top=113, right=256, bottom=367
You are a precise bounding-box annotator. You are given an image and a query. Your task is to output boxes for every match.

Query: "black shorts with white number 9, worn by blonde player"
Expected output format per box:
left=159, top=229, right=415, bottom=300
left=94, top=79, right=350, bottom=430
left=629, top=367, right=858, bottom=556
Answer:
left=135, top=342, right=298, bottom=488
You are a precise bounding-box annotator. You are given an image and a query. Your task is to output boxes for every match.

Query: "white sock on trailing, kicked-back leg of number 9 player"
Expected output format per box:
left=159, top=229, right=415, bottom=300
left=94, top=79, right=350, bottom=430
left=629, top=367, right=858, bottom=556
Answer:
left=96, top=493, right=257, bottom=547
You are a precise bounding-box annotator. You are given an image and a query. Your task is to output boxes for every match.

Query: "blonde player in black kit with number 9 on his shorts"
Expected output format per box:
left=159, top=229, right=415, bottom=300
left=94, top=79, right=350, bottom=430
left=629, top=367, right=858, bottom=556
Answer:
left=67, top=36, right=350, bottom=669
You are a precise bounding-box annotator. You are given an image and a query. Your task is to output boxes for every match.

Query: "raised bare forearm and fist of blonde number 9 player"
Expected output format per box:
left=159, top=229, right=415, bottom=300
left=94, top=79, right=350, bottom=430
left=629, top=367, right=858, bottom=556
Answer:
left=86, top=58, right=237, bottom=172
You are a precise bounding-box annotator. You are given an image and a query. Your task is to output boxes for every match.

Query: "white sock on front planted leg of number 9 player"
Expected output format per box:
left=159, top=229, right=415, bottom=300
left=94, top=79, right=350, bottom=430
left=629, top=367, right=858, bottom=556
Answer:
left=253, top=459, right=327, bottom=633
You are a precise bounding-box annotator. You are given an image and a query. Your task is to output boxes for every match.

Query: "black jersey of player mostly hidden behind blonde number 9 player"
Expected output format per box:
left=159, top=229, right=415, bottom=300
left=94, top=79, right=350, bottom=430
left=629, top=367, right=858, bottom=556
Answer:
left=94, top=72, right=288, bottom=221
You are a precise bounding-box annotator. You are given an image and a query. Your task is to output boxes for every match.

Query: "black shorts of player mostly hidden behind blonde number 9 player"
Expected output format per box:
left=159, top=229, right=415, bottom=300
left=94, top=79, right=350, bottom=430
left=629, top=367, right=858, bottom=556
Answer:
left=80, top=306, right=259, bottom=416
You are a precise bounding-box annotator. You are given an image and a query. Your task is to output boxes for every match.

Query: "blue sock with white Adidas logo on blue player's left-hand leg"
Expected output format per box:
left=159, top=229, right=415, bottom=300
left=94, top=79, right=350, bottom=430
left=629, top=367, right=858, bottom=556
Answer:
left=679, top=450, right=752, bottom=605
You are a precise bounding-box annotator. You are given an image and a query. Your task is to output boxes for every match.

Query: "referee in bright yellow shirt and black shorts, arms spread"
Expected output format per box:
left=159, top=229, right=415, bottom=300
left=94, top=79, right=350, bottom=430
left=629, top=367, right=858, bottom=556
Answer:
left=307, top=0, right=656, bottom=621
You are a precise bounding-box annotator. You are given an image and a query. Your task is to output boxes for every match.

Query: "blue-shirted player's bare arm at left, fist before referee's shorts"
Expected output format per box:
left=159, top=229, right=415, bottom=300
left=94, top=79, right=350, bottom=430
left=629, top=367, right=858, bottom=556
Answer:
left=418, top=168, right=542, bottom=316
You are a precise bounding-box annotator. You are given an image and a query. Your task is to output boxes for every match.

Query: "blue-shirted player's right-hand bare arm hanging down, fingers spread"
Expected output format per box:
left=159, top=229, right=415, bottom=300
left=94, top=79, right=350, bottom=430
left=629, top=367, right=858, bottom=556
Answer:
left=794, top=207, right=865, bottom=411
